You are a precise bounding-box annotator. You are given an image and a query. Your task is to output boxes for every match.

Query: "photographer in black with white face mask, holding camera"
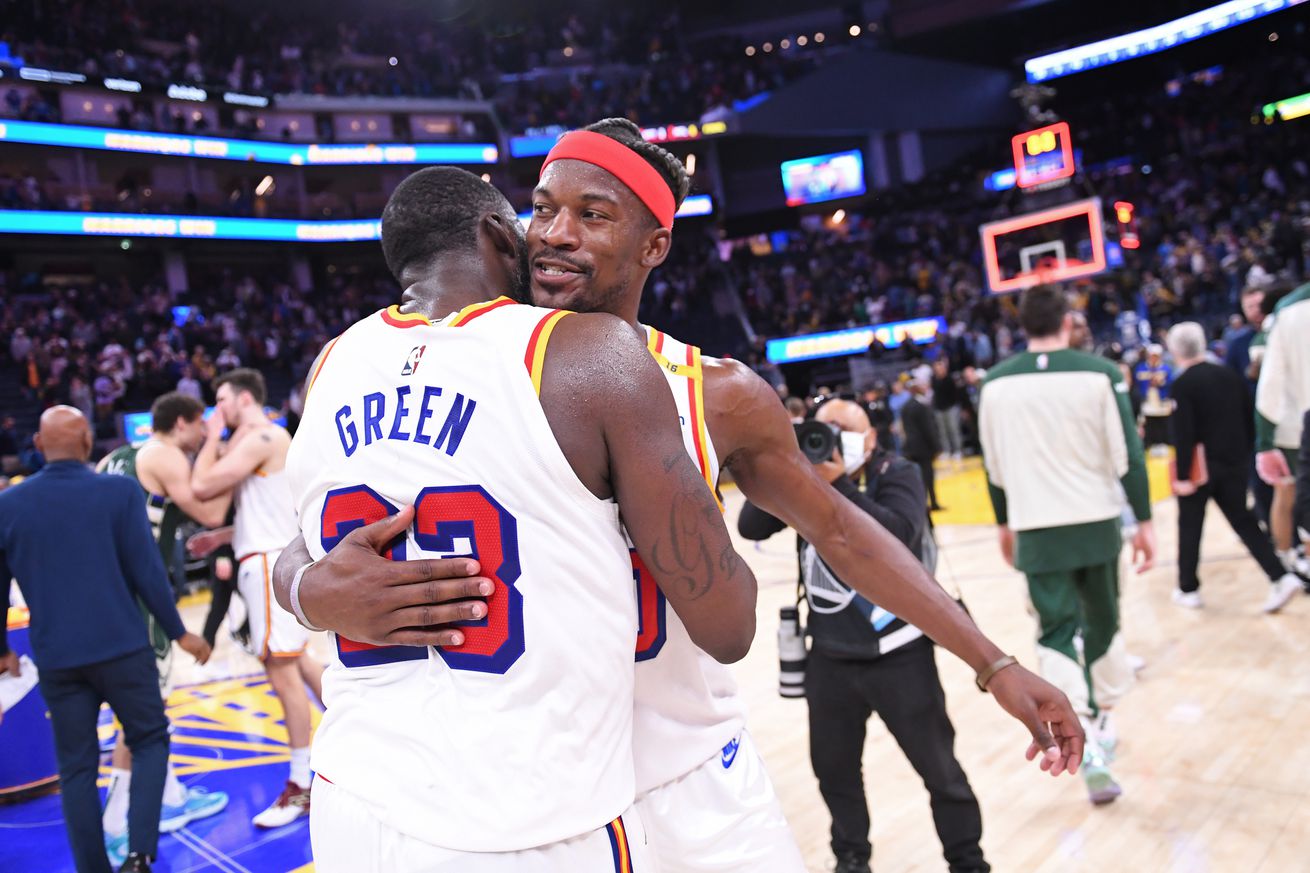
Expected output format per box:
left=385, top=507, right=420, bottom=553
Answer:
left=738, top=400, right=990, bottom=873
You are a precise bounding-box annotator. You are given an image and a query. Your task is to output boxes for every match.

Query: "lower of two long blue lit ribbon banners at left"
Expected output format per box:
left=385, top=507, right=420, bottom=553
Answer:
left=0, top=210, right=383, bottom=243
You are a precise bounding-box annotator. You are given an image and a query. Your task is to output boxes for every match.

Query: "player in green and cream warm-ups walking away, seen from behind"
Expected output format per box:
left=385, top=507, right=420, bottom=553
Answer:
left=979, top=287, right=1155, bottom=804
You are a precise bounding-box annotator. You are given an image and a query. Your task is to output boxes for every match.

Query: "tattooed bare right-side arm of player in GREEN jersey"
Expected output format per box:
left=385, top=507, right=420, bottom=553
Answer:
left=541, top=313, right=756, bottom=663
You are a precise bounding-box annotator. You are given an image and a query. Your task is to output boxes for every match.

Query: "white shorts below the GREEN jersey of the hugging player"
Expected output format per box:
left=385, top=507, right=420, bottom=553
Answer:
left=309, top=776, right=656, bottom=873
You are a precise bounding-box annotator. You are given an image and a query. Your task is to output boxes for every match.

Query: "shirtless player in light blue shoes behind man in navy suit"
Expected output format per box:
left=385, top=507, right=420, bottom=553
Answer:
left=97, top=392, right=231, bottom=868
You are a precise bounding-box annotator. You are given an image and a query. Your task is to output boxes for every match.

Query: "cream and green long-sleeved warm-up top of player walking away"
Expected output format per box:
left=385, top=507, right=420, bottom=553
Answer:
left=979, top=349, right=1150, bottom=573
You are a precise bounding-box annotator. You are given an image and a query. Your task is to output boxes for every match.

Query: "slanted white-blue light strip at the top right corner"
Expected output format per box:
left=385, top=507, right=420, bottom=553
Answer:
left=1023, top=0, right=1306, bottom=83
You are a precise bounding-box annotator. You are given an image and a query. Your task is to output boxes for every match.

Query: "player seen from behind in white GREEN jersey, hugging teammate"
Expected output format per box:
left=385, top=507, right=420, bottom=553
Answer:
left=287, top=168, right=755, bottom=873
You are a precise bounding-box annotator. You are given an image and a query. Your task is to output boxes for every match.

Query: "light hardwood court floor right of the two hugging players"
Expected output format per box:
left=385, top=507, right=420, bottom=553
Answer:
left=728, top=461, right=1310, bottom=873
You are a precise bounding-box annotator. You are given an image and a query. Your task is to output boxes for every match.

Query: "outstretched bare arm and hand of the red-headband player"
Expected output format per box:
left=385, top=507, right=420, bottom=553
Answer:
left=705, top=360, right=1083, bottom=773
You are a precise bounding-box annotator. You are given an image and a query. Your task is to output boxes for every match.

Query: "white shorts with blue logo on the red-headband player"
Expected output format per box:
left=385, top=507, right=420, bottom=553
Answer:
left=637, top=730, right=806, bottom=873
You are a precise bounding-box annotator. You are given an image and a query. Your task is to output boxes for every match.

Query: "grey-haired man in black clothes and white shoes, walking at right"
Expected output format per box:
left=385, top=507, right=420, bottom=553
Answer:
left=1169, top=321, right=1301, bottom=612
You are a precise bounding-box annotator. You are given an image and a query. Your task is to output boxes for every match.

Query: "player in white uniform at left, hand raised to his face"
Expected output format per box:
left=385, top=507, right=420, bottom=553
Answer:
left=191, top=368, right=322, bottom=828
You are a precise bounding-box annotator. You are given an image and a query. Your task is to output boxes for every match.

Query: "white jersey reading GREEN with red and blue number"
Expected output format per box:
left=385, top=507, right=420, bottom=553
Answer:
left=287, top=298, right=637, bottom=852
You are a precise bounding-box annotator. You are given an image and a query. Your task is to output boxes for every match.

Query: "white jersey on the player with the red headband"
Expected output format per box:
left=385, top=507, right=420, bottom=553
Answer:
left=633, top=322, right=745, bottom=794
